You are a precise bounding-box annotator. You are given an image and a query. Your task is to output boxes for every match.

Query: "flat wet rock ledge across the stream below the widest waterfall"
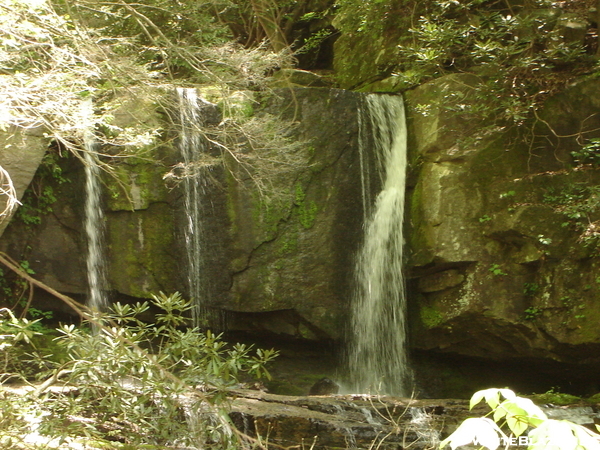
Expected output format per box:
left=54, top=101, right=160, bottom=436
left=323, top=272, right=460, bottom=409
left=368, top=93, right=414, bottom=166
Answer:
left=224, top=390, right=600, bottom=450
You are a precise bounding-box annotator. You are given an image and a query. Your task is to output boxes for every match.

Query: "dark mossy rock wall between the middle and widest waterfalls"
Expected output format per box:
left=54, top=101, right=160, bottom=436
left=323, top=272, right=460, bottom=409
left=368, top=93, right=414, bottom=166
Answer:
left=225, top=89, right=362, bottom=339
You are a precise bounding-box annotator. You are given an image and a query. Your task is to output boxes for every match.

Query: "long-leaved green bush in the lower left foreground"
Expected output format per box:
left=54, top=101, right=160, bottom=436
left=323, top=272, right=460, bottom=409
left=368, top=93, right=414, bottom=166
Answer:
left=0, top=294, right=276, bottom=449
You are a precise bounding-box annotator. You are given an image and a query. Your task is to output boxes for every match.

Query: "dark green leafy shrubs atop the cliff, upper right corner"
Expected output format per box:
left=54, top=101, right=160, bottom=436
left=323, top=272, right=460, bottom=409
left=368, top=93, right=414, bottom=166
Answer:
left=399, top=0, right=596, bottom=125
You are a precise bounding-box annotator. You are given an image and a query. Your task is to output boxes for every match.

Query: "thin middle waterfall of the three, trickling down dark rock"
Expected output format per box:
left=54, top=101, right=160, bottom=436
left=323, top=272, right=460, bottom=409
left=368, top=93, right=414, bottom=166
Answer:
left=177, top=88, right=209, bottom=326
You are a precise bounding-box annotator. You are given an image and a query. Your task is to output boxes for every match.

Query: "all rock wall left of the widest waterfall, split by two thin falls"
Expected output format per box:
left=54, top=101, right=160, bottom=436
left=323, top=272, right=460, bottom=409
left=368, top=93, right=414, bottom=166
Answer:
left=2, top=88, right=376, bottom=340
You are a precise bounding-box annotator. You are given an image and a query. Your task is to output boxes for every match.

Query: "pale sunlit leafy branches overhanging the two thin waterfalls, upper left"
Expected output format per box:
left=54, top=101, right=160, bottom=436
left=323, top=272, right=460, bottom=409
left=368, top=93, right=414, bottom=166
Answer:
left=0, top=0, right=300, bottom=169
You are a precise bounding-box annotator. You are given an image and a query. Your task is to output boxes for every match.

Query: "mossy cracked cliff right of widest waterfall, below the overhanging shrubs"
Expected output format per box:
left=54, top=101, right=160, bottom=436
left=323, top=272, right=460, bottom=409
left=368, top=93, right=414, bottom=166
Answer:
left=407, top=76, right=600, bottom=389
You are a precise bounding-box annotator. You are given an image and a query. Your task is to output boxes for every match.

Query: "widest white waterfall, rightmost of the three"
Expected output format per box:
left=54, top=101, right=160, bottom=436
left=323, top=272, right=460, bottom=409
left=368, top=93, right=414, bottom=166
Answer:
left=348, top=94, right=410, bottom=395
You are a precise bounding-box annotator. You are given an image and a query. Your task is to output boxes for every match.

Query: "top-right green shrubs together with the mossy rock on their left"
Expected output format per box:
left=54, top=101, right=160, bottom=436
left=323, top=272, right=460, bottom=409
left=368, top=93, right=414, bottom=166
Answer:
left=335, top=0, right=598, bottom=136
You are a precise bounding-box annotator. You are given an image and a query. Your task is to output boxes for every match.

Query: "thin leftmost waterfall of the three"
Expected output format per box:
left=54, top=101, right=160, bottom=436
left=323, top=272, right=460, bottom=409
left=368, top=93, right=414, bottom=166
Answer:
left=81, top=99, right=108, bottom=311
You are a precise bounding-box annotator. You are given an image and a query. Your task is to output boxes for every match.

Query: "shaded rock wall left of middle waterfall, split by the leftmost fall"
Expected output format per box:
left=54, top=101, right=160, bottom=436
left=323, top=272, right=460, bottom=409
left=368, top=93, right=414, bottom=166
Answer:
left=0, top=90, right=176, bottom=306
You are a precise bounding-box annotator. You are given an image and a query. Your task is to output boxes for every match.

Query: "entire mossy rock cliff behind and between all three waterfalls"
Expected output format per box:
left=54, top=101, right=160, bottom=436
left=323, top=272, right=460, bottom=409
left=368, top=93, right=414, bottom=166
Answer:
left=5, top=19, right=600, bottom=395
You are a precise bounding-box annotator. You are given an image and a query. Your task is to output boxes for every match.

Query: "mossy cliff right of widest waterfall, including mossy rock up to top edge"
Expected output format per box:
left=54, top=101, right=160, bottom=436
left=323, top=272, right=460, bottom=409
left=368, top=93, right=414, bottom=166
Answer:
left=334, top=0, right=600, bottom=395
